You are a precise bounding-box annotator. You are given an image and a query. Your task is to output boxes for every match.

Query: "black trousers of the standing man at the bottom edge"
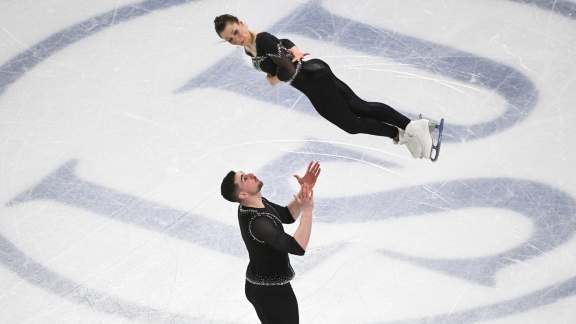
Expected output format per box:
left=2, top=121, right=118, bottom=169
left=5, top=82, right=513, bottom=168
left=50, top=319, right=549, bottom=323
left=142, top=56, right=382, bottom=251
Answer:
left=245, top=281, right=299, bottom=324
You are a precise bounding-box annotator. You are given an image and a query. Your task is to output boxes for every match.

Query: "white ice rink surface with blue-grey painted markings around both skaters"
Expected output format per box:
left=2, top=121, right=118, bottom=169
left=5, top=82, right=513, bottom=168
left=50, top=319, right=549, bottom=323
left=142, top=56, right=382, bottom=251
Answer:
left=0, top=0, right=576, bottom=324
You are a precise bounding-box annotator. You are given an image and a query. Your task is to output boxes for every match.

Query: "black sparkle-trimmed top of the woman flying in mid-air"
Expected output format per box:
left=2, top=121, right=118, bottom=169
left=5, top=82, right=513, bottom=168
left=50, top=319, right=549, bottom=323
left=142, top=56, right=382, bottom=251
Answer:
left=246, top=32, right=300, bottom=82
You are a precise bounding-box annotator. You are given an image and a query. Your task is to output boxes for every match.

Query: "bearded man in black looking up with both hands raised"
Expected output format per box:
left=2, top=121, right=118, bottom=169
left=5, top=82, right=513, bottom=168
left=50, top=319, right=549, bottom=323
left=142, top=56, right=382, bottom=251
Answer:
left=220, top=162, right=320, bottom=324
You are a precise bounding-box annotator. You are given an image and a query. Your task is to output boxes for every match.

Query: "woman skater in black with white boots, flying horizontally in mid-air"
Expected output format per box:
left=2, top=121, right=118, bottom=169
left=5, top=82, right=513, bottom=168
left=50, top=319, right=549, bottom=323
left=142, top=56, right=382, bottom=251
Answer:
left=214, top=14, right=432, bottom=159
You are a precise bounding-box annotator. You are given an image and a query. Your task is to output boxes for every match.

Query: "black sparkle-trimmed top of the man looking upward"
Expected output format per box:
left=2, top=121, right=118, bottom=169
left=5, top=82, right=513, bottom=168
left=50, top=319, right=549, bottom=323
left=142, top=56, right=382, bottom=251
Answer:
left=238, top=198, right=305, bottom=285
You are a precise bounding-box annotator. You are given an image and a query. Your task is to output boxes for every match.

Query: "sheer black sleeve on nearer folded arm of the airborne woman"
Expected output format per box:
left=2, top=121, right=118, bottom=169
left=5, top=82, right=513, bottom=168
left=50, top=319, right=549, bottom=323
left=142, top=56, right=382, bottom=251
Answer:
left=256, top=32, right=296, bottom=82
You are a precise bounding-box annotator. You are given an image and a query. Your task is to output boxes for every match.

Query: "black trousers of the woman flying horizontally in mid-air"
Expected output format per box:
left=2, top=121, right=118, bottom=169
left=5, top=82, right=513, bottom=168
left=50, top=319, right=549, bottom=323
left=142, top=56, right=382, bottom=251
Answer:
left=291, top=59, right=410, bottom=138
